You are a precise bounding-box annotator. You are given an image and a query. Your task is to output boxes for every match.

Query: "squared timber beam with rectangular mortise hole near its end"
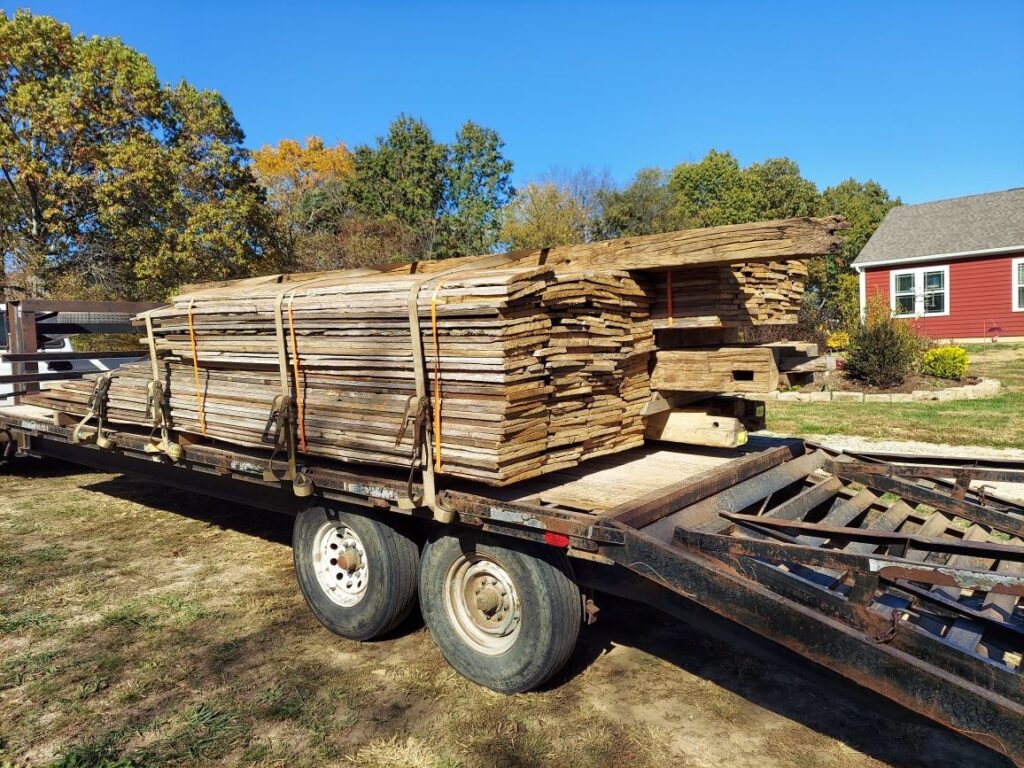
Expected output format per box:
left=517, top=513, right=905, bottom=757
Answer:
left=650, top=347, right=778, bottom=392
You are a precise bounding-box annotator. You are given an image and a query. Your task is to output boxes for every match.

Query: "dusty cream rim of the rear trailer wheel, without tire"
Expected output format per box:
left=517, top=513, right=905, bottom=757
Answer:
left=444, top=553, right=522, bottom=655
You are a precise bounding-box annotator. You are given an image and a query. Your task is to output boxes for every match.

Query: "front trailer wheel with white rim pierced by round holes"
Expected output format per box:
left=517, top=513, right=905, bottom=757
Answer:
left=292, top=506, right=420, bottom=640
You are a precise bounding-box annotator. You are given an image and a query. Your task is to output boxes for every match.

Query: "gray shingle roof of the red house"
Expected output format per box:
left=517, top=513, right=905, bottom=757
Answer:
left=853, top=187, right=1024, bottom=265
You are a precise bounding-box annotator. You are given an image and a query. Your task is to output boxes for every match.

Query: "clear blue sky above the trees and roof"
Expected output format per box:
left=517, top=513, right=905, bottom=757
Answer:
left=14, top=0, right=1024, bottom=203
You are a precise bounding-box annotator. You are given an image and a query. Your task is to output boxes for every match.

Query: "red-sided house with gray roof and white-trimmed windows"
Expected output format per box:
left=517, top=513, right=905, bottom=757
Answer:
left=853, top=188, right=1024, bottom=341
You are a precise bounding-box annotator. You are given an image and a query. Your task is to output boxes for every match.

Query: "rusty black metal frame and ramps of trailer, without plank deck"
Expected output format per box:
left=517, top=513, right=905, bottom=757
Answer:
left=0, top=409, right=1024, bottom=764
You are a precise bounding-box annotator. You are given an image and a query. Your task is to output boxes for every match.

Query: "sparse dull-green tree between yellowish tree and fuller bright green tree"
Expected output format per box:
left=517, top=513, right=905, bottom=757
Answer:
left=597, top=168, right=683, bottom=240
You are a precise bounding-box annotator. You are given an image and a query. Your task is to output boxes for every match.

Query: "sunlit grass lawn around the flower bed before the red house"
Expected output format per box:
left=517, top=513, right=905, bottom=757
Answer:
left=768, top=344, right=1024, bottom=449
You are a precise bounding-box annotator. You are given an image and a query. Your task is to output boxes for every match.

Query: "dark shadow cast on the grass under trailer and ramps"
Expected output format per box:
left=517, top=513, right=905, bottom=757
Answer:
left=17, top=462, right=1010, bottom=768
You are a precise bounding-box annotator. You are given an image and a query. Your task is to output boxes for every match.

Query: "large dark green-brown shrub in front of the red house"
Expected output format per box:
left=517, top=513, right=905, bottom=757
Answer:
left=845, top=301, right=928, bottom=388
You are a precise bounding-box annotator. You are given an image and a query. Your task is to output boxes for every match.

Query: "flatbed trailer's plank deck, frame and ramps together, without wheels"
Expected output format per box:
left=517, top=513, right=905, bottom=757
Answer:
left=0, top=406, right=1024, bottom=764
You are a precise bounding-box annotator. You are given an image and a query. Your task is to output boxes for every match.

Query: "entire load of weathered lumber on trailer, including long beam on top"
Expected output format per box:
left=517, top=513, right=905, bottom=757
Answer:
left=34, top=217, right=845, bottom=484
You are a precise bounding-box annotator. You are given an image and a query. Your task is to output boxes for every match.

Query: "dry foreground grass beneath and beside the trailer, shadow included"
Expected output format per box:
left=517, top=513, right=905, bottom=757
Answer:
left=0, top=461, right=1008, bottom=768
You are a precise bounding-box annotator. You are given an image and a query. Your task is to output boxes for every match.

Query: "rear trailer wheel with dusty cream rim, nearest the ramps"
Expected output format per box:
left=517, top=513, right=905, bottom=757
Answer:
left=420, top=536, right=582, bottom=693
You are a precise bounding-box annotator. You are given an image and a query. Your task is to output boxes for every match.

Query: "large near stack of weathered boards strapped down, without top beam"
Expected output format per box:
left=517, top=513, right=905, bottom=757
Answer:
left=37, top=267, right=653, bottom=484
